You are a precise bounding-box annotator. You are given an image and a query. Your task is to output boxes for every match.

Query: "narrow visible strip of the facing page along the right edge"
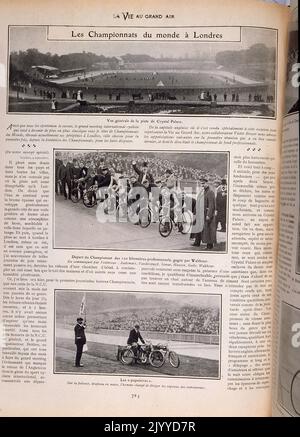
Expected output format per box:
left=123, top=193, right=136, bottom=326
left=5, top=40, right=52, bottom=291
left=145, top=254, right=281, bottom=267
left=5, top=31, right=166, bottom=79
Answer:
left=273, top=1, right=300, bottom=417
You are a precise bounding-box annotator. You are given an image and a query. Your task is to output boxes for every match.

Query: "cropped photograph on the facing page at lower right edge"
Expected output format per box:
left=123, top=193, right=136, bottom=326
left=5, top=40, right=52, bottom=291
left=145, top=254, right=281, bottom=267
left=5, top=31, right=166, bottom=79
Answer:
left=278, top=302, right=300, bottom=417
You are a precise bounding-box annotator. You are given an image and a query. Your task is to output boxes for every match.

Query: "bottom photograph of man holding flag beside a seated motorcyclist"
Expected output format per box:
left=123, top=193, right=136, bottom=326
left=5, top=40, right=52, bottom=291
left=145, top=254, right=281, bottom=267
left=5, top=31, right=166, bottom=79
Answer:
left=54, top=290, right=222, bottom=379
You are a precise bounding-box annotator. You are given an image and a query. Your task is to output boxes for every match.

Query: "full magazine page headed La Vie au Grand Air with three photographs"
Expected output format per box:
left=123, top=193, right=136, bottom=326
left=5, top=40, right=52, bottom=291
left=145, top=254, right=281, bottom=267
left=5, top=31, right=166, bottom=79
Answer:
left=0, top=0, right=289, bottom=416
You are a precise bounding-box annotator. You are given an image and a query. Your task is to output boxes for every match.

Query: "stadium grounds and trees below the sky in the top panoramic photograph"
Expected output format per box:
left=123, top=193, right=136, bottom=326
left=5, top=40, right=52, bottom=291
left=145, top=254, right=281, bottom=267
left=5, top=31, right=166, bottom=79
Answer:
left=9, top=24, right=276, bottom=116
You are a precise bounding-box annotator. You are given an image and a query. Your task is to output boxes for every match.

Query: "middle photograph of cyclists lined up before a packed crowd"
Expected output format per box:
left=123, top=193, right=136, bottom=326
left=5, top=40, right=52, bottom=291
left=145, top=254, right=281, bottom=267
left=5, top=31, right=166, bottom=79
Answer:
left=53, top=149, right=230, bottom=253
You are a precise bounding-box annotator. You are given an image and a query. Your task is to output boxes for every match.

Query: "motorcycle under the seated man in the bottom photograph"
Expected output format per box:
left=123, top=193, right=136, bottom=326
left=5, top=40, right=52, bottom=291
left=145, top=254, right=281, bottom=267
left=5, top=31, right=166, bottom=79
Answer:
left=118, top=342, right=164, bottom=368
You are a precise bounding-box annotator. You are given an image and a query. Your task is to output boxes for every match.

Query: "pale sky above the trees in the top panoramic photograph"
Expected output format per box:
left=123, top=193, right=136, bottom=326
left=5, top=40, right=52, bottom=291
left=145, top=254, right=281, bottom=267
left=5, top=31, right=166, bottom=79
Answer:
left=10, top=26, right=276, bottom=59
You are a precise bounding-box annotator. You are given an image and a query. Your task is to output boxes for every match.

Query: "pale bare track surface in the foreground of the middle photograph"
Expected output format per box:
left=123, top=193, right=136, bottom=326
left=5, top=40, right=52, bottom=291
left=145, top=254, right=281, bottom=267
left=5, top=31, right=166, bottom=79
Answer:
left=54, top=195, right=226, bottom=252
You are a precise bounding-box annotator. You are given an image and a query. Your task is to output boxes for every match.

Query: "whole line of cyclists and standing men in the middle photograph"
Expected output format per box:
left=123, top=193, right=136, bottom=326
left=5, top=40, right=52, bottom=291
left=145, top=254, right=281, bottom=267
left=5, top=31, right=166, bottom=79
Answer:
left=55, top=154, right=227, bottom=249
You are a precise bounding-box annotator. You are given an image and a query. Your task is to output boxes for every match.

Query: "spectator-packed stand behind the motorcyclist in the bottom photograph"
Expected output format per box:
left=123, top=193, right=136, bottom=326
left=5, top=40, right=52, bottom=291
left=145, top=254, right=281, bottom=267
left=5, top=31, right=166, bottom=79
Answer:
left=57, top=293, right=220, bottom=342
